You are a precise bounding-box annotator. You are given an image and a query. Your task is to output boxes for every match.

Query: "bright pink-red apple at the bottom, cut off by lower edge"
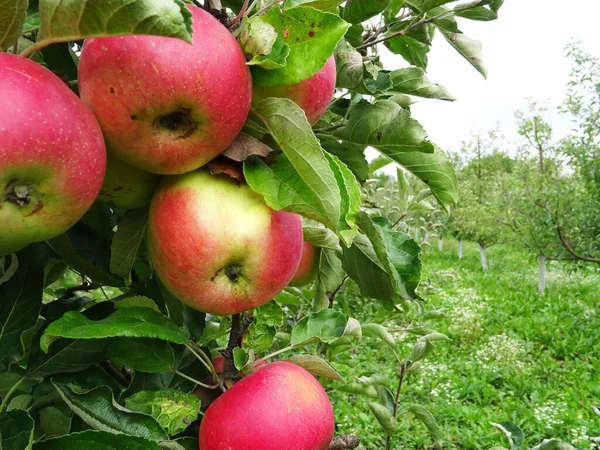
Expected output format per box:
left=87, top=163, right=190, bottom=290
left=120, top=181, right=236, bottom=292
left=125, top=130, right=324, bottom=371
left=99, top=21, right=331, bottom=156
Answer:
left=200, top=361, right=334, bottom=450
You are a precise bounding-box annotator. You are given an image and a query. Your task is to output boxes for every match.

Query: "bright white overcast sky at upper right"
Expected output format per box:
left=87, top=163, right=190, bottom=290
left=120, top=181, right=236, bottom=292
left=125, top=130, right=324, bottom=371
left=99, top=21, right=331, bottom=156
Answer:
left=383, top=0, right=600, bottom=155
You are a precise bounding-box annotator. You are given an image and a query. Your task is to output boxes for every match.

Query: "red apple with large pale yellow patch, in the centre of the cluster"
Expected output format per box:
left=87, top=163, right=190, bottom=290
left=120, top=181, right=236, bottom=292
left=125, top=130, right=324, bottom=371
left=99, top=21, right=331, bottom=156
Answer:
left=147, top=168, right=303, bottom=315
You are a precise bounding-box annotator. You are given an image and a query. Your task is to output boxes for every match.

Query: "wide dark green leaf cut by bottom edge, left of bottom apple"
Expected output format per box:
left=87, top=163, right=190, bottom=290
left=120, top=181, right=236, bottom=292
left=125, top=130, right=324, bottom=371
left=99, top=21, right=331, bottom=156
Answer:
left=33, top=430, right=160, bottom=450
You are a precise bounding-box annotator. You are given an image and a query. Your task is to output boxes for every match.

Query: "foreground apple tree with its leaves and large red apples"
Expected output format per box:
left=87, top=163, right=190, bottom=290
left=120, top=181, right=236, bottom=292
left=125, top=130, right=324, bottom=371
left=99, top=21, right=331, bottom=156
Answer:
left=0, top=0, right=503, bottom=450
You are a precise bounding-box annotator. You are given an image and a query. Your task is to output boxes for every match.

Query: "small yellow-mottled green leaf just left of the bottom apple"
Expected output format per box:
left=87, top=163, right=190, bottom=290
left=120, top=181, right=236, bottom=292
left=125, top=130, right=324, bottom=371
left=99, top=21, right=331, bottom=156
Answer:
left=125, top=389, right=200, bottom=436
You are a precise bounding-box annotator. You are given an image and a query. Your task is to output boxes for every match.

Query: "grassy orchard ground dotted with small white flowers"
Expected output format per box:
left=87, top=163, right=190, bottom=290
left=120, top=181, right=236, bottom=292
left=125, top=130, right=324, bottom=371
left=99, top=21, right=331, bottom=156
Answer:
left=332, top=242, right=600, bottom=449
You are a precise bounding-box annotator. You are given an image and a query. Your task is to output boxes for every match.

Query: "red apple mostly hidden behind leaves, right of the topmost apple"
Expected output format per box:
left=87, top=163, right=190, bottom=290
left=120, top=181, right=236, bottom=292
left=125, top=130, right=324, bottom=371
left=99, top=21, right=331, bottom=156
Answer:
left=252, top=56, right=336, bottom=125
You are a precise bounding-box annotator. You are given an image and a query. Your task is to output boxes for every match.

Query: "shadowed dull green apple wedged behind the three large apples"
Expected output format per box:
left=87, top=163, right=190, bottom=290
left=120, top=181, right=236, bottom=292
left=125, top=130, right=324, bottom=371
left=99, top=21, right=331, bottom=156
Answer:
left=98, top=153, right=161, bottom=209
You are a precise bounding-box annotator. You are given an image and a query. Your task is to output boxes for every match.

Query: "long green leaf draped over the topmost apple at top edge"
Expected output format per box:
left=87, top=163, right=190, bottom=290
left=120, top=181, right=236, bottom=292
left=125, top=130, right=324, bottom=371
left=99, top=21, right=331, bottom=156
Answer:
left=30, top=0, right=192, bottom=55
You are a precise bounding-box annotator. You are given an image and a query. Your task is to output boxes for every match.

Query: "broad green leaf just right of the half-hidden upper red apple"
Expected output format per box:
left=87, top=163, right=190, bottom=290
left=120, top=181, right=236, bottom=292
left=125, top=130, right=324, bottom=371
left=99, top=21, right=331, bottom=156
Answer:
left=335, top=100, right=434, bottom=155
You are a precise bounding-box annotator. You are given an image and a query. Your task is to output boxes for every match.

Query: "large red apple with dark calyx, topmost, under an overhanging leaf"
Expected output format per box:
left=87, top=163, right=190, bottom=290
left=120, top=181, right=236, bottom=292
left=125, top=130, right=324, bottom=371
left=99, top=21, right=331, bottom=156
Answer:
left=79, top=5, right=252, bottom=174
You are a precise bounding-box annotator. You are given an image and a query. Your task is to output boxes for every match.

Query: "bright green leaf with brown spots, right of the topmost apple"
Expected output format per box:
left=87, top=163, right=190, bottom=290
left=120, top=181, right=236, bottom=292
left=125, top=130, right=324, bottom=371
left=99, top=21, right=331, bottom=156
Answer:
left=251, top=6, right=350, bottom=86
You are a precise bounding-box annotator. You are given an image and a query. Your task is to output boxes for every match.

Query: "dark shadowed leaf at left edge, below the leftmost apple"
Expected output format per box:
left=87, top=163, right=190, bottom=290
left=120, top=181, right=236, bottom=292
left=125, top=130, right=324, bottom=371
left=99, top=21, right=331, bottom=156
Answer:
left=0, top=244, right=46, bottom=374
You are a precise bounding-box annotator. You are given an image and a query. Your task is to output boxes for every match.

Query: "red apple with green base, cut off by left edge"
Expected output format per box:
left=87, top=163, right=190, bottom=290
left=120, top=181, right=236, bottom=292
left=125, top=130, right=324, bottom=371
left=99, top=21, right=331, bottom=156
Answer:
left=0, top=53, right=106, bottom=256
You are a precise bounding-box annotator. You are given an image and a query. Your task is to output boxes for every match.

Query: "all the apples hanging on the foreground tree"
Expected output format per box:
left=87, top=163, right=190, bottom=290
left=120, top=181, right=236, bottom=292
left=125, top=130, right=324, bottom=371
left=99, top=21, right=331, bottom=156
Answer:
left=0, top=5, right=336, bottom=450
